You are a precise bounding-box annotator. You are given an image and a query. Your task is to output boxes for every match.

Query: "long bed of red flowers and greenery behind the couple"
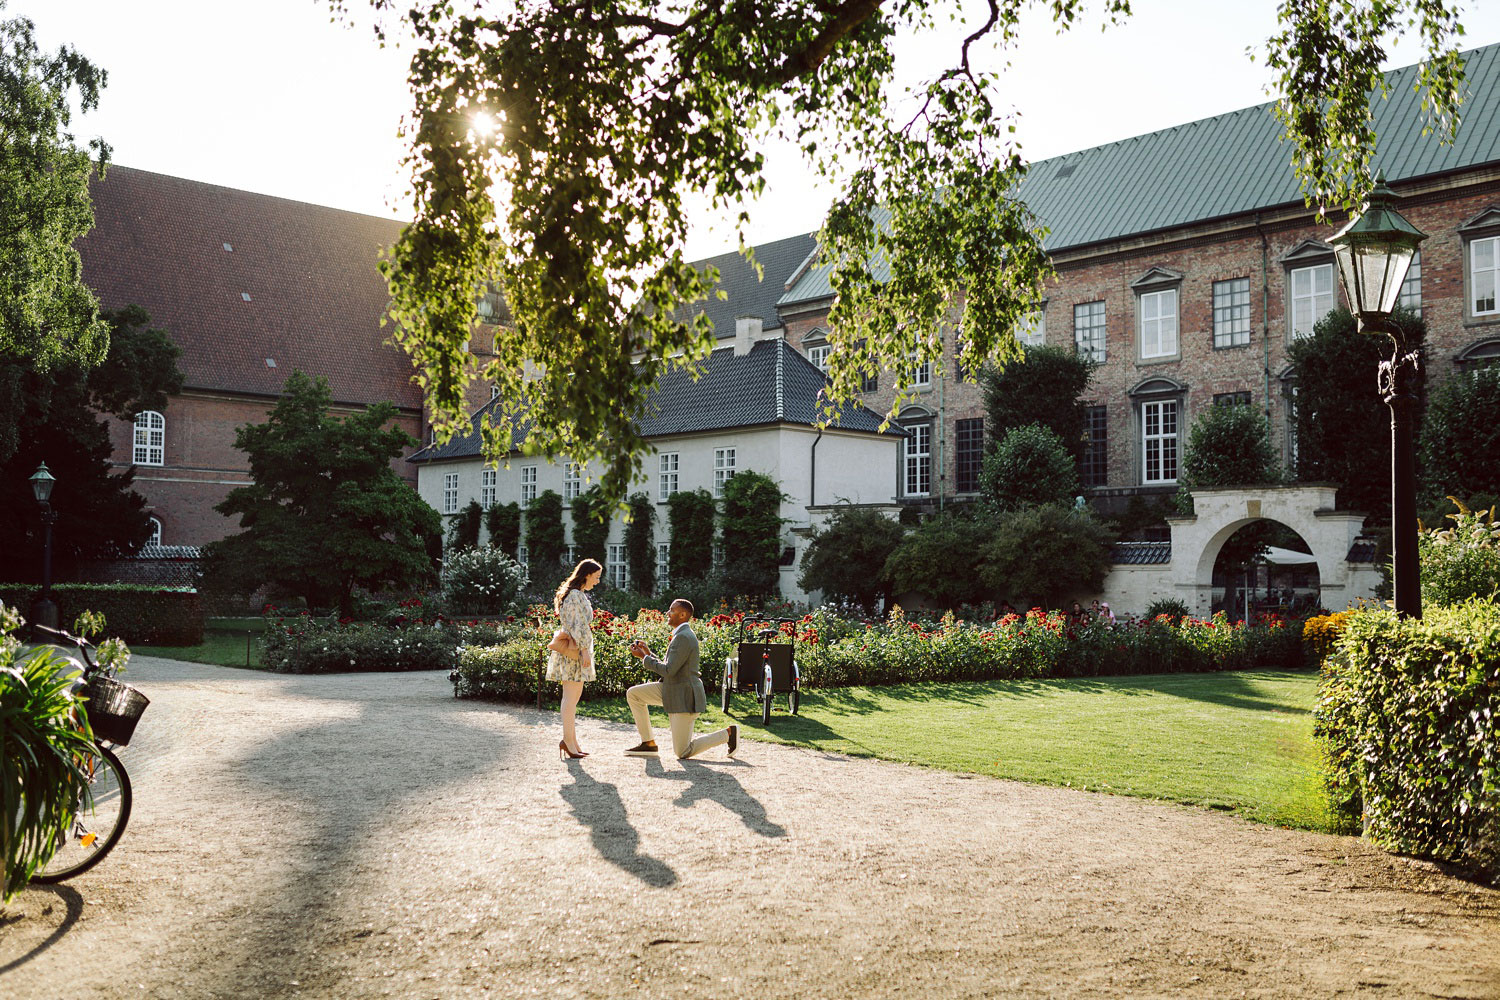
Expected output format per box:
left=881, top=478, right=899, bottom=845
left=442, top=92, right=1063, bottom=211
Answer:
left=455, top=609, right=1311, bottom=700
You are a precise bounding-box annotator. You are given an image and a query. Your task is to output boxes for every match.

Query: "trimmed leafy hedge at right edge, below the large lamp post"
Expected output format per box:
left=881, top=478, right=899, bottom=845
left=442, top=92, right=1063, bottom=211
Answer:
left=1314, top=601, right=1500, bottom=877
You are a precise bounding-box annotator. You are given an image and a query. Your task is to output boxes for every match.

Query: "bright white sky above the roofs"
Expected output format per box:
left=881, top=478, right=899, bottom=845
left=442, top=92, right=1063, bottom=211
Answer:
left=11, top=0, right=1500, bottom=258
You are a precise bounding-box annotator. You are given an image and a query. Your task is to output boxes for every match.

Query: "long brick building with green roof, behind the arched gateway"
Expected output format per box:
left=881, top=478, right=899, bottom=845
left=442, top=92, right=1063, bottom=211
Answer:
left=777, top=45, right=1500, bottom=507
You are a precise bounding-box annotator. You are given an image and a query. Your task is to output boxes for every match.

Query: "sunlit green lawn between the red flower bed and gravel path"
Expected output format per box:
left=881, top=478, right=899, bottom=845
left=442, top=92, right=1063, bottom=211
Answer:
left=579, top=670, right=1328, bottom=829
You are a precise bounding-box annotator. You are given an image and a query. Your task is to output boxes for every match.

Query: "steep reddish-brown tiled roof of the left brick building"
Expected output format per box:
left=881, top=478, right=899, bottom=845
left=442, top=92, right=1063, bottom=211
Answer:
left=78, top=166, right=422, bottom=409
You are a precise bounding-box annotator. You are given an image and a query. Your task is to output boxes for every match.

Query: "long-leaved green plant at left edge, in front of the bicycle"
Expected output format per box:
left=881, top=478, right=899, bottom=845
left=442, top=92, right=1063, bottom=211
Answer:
left=0, top=604, right=93, bottom=903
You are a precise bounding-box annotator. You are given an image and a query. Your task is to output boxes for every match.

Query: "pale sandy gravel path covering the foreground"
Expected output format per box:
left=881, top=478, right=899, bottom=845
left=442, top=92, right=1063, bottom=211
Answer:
left=0, top=657, right=1500, bottom=1000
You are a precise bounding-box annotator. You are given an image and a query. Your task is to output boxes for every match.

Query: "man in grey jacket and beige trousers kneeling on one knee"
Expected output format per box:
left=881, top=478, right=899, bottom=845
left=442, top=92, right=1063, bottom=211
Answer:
left=626, top=598, right=740, bottom=759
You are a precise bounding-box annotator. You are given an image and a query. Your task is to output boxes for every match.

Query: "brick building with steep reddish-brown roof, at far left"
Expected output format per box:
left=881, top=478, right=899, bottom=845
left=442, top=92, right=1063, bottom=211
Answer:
left=78, top=166, right=426, bottom=546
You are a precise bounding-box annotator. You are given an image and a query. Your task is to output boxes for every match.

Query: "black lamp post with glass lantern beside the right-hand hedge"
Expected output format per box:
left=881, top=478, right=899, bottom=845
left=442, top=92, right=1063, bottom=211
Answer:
left=1329, top=177, right=1427, bottom=618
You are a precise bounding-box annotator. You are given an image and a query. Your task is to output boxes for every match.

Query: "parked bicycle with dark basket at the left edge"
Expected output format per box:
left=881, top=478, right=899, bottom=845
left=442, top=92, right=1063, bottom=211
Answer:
left=32, top=625, right=150, bottom=885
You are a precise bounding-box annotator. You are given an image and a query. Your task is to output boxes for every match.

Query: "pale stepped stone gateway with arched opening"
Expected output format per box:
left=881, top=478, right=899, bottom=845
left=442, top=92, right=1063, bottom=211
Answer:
left=1101, top=484, right=1380, bottom=616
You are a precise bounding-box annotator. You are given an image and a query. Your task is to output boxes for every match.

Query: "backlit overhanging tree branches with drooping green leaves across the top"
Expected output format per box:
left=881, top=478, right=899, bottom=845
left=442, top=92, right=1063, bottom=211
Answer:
left=330, top=0, right=1463, bottom=499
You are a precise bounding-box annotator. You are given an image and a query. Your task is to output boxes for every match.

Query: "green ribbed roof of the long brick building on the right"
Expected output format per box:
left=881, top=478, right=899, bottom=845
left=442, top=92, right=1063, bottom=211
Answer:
left=777, top=45, right=1500, bottom=307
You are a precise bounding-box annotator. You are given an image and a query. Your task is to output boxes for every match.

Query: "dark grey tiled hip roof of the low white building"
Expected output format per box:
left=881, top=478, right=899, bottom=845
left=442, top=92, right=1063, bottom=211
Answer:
left=408, top=339, right=905, bottom=462
